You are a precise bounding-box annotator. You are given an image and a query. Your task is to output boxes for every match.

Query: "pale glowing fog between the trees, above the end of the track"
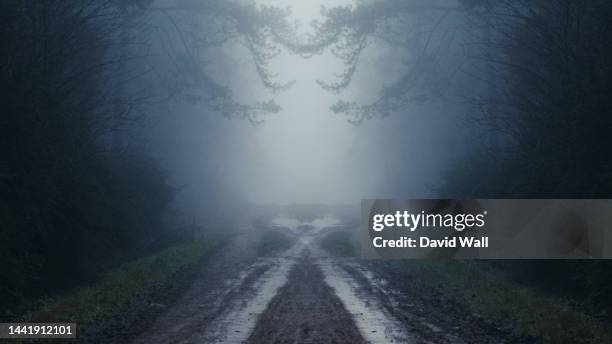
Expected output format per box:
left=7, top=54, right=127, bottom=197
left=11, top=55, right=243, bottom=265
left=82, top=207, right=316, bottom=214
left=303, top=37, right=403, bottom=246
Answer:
left=142, top=0, right=469, bottom=209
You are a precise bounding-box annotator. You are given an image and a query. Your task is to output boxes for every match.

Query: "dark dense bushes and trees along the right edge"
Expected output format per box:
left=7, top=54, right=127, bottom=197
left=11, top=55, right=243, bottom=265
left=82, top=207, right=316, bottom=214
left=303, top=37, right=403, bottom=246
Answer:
left=439, top=0, right=612, bottom=318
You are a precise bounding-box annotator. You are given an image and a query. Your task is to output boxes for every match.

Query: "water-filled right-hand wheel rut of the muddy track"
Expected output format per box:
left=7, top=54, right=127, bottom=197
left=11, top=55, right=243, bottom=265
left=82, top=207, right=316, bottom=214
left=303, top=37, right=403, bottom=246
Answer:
left=318, top=259, right=416, bottom=344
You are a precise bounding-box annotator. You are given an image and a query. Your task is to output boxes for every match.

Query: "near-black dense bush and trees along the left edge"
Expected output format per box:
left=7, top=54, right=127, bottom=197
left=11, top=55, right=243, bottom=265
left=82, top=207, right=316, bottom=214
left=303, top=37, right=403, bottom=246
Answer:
left=0, top=0, right=172, bottom=314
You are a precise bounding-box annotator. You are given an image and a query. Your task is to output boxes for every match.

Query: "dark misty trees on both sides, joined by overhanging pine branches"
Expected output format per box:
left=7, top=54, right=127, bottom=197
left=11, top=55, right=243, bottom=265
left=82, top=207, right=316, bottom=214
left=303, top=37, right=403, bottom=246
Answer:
left=0, top=0, right=612, bottom=322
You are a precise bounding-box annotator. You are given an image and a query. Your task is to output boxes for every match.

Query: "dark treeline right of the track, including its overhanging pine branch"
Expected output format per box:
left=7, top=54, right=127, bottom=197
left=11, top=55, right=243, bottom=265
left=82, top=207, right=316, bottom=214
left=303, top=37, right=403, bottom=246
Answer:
left=311, top=0, right=612, bottom=314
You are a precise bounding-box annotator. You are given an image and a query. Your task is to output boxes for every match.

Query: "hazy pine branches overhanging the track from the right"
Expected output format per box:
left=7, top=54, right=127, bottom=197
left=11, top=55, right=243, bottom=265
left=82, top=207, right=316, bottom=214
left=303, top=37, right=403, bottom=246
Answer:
left=302, top=0, right=470, bottom=125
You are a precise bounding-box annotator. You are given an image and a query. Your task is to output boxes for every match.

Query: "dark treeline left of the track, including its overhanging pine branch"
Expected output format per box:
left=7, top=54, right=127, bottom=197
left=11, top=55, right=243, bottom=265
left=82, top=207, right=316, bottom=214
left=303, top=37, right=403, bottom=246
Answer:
left=0, top=0, right=288, bottom=313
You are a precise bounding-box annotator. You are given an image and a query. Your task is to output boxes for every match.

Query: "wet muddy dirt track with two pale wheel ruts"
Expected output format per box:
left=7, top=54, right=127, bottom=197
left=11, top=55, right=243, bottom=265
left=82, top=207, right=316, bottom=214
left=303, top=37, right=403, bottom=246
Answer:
left=133, top=218, right=503, bottom=344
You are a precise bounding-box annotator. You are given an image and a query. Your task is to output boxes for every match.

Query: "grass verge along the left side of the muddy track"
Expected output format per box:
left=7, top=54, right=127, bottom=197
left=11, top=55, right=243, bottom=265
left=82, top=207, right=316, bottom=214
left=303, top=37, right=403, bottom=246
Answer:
left=22, top=232, right=230, bottom=342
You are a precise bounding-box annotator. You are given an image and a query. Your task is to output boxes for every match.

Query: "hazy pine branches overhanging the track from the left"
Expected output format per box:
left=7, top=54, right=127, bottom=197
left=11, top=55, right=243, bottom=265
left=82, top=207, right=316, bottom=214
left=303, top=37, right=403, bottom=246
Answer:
left=149, top=0, right=295, bottom=124
